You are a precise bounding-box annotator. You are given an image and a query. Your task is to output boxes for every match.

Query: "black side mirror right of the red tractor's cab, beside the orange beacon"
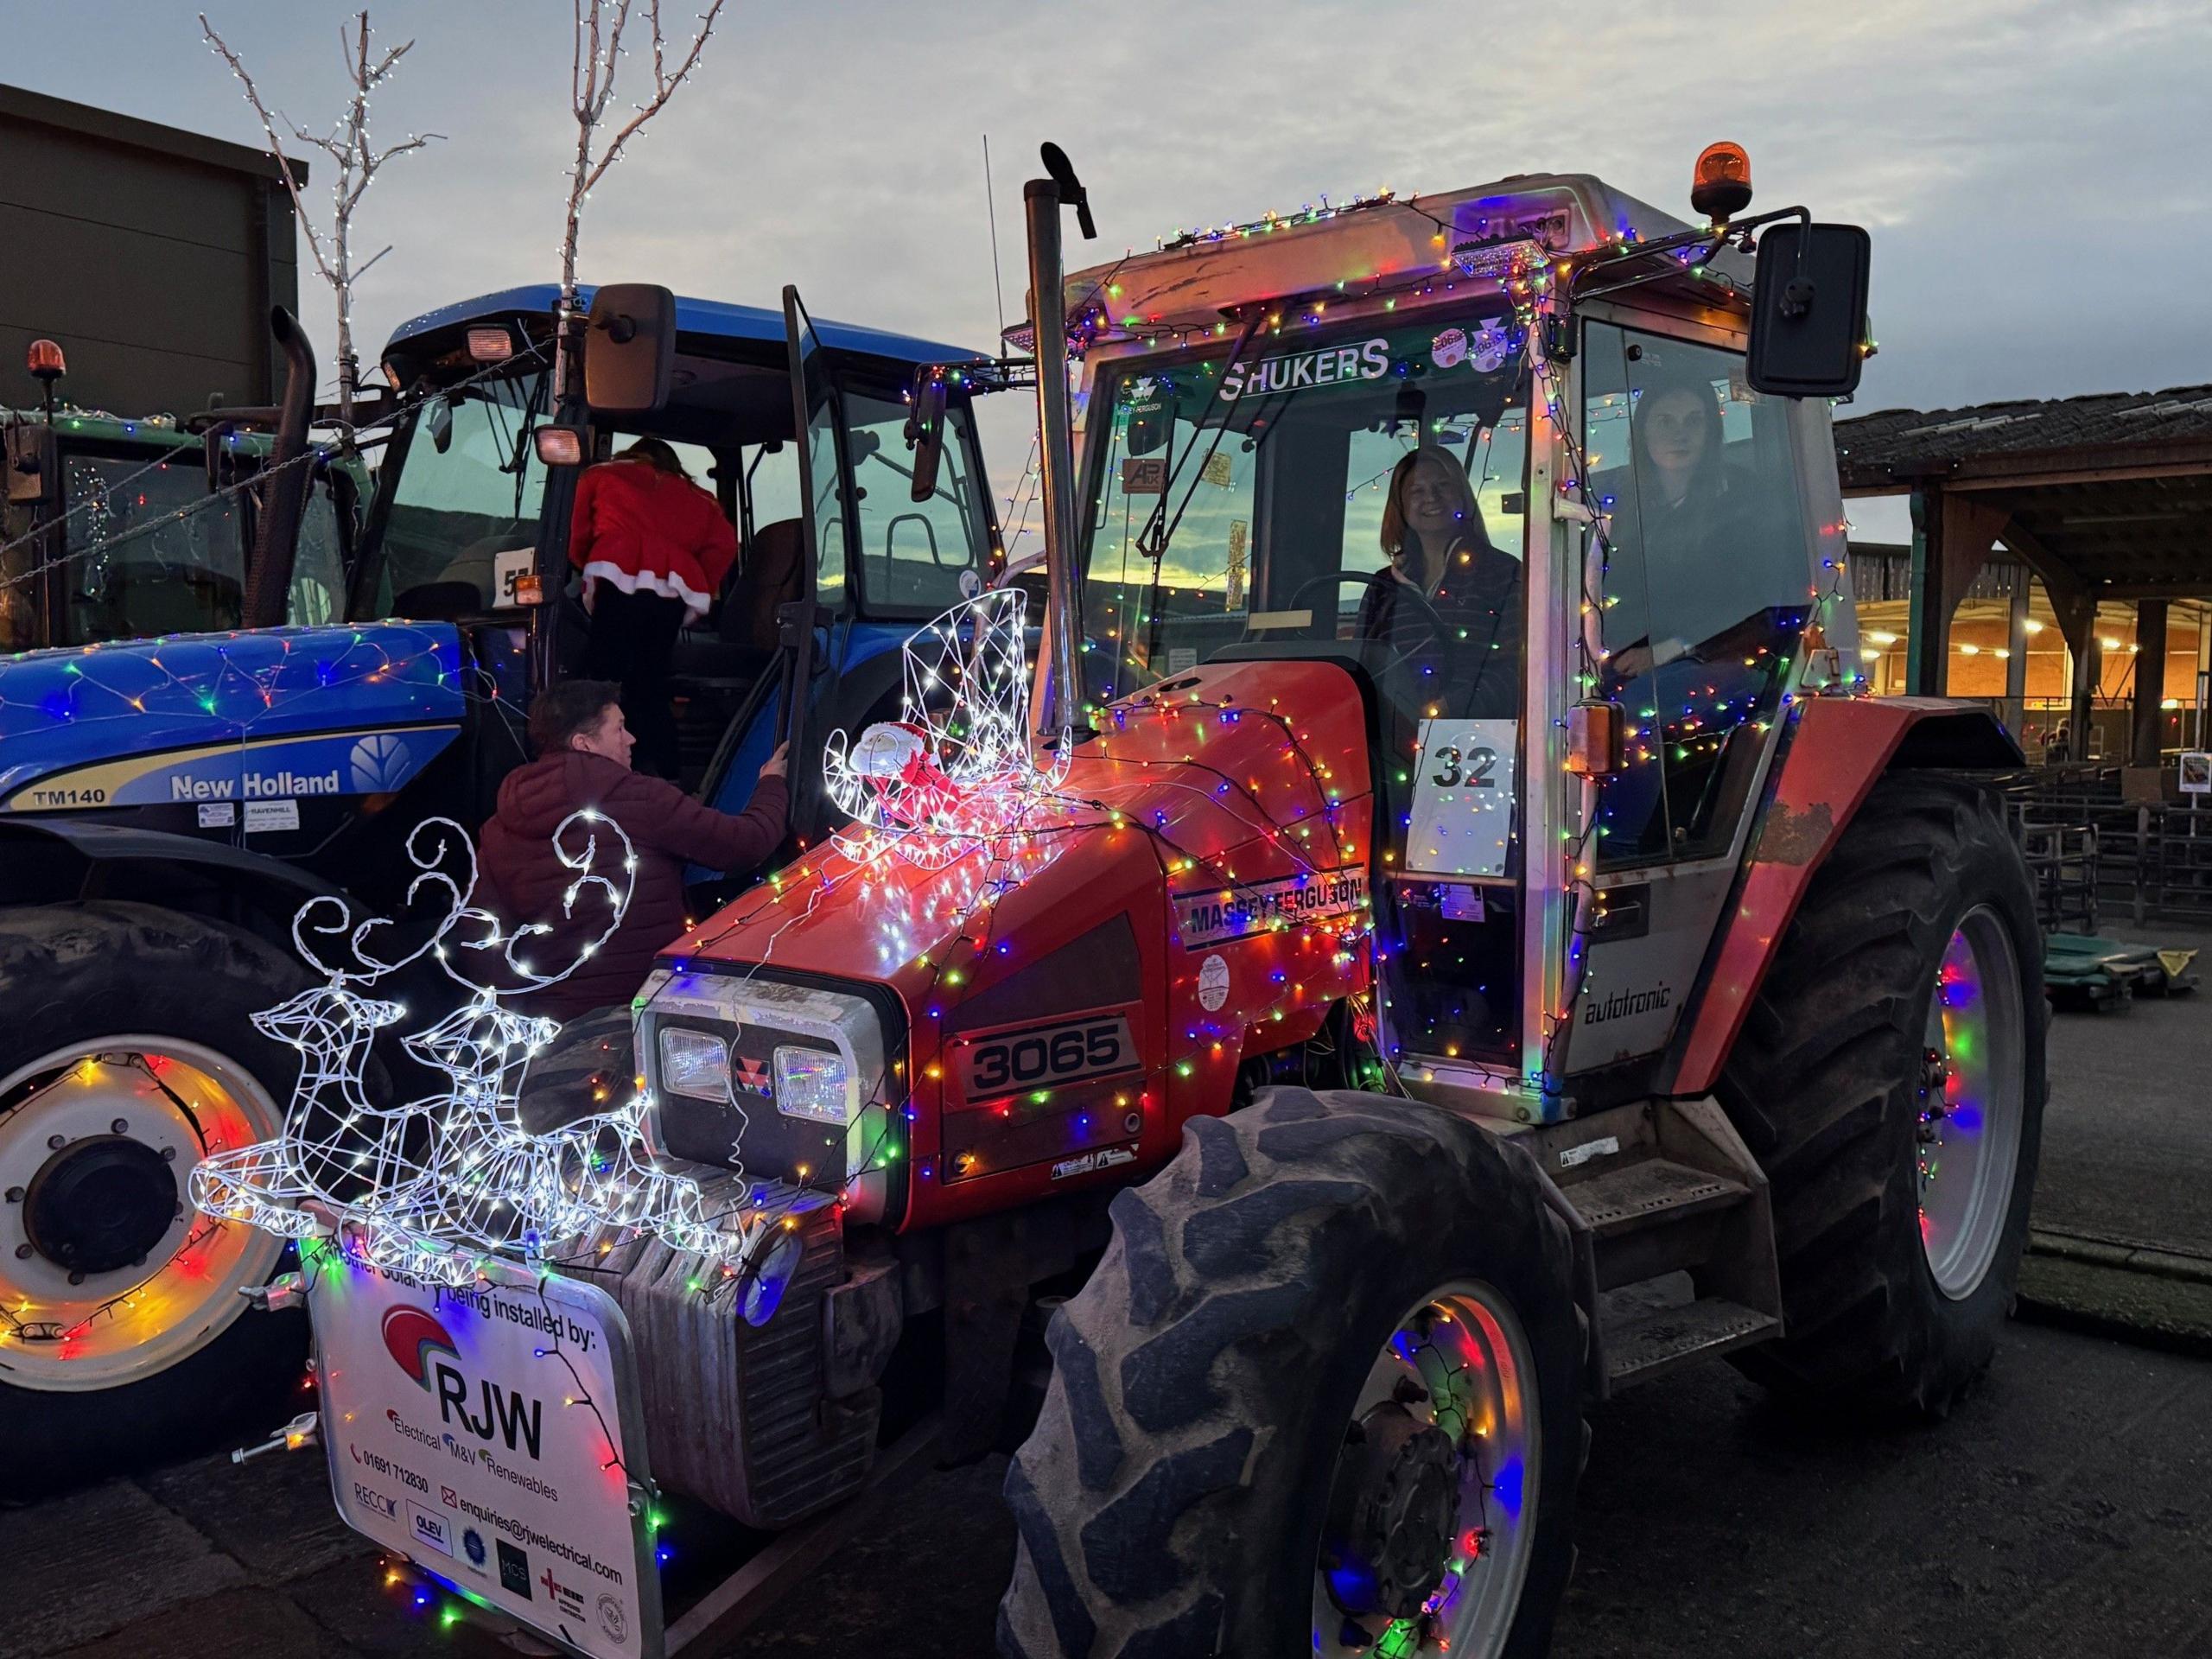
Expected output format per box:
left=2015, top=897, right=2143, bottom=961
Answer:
left=1745, top=224, right=1873, bottom=398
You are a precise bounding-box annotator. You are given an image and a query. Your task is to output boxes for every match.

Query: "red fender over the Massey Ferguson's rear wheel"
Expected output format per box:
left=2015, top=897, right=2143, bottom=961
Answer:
left=1655, top=696, right=2022, bottom=1095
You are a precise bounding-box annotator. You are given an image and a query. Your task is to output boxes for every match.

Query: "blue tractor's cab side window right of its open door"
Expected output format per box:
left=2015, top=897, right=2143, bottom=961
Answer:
left=845, top=391, right=984, bottom=617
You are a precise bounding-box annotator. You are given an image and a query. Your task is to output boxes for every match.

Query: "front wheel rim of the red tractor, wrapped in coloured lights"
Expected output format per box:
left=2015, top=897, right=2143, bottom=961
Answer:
left=1312, top=1281, right=1541, bottom=1659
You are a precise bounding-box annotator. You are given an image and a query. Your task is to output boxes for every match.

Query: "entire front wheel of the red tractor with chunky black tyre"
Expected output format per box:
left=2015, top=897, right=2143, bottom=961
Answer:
left=1000, top=1089, right=1584, bottom=1659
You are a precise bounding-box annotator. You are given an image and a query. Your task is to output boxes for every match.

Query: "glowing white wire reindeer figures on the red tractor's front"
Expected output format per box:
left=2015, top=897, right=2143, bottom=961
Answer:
left=193, top=807, right=766, bottom=1287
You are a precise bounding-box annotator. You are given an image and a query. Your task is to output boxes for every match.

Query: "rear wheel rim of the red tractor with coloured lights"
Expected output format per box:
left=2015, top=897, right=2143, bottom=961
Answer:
left=1913, top=905, right=2026, bottom=1300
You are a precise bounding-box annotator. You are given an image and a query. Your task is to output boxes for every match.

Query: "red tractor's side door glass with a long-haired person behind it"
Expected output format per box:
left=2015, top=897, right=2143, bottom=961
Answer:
left=1584, top=323, right=1812, bottom=868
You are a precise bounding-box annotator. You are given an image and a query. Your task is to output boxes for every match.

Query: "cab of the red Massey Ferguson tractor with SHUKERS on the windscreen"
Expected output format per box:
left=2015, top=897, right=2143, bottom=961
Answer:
left=1066, top=175, right=1856, bottom=1117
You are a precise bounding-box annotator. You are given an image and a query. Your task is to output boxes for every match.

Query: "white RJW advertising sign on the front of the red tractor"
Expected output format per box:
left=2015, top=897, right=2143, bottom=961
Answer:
left=308, top=1245, right=661, bottom=1659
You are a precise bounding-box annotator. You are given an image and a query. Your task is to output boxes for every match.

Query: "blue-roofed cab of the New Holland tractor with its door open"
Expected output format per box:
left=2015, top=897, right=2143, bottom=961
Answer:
left=352, top=285, right=1000, bottom=823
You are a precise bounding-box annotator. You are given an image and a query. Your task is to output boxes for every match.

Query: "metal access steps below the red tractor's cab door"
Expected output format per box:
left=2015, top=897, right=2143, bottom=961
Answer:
left=1516, top=1099, right=1781, bottom=1395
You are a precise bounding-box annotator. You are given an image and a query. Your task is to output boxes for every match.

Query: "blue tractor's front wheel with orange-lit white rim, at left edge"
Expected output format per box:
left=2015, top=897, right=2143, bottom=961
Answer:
left=0, top=902, right=308, bottom=1493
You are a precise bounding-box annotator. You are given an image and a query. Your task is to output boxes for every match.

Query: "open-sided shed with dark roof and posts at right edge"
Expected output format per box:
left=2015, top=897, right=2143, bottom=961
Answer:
left=1836, top=385, right=2212, bottom=766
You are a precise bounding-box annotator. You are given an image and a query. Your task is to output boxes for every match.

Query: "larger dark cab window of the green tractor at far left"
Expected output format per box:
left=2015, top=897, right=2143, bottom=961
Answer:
left=62, top=451, right=245, bottom=646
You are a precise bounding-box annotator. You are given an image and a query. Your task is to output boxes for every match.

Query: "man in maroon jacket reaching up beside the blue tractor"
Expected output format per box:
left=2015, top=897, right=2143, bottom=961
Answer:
left=475, top=679, right=787, bottom=1020
